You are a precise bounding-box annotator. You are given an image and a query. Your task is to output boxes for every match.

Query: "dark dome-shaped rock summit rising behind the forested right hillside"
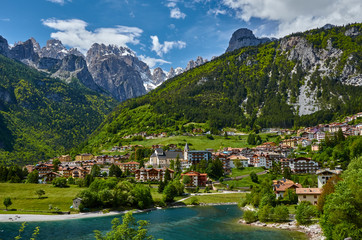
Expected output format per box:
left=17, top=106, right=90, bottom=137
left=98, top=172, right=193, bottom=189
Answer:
left=226, top=28, right=271, bottom=52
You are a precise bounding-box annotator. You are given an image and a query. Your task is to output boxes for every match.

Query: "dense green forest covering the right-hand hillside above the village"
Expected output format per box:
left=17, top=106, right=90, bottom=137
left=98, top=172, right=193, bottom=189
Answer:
left=78, top=24, right=362, bottom=151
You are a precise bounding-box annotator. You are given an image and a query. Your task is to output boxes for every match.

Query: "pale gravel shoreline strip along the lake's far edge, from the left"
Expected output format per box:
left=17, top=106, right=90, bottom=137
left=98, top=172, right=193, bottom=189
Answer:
left=0, top=202, right=236, bottom=222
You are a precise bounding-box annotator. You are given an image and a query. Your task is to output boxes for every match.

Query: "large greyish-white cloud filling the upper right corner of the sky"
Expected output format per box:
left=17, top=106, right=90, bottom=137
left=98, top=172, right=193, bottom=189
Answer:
left=223, top=0, right=362, bottom=37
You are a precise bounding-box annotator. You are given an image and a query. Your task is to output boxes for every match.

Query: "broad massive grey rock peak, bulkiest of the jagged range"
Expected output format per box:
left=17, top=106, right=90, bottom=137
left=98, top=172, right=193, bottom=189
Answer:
left=86, top=44, right=146, bottom=101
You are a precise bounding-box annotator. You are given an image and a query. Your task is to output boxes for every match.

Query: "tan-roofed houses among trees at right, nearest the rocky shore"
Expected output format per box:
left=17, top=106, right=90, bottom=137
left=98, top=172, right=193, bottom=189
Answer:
left=273, top=168, right=342, bottom=205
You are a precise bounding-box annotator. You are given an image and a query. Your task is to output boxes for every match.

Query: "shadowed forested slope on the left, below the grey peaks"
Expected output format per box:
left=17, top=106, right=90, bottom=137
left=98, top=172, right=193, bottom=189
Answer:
left=0, top=55, right=116, bottom=163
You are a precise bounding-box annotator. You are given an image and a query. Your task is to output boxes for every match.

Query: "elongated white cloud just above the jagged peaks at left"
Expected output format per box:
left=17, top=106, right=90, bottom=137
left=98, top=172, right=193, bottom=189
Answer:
left=42, top=18, right=143, bottom=53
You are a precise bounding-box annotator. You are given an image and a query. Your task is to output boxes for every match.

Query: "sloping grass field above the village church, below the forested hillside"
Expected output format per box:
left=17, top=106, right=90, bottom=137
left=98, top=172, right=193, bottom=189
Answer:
left=102, top=134, right=275, bottom=153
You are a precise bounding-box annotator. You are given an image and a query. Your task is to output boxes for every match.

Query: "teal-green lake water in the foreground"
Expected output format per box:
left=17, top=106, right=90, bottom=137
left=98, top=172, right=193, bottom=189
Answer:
left=0, top=205, right=306, bottom=240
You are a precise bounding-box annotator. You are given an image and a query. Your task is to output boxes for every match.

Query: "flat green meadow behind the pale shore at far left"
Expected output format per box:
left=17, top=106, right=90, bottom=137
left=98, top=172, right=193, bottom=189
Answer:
left=0, top=183, right=83, bottom=213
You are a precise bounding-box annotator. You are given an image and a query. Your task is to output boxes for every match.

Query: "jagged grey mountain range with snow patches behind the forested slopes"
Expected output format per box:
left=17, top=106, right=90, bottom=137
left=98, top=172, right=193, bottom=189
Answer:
left=0, top=36, right=207, bottom=102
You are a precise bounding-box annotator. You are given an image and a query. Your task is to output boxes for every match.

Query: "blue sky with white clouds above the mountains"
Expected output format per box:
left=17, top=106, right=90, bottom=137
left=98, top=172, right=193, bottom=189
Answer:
left=0, top=0, right=362, bottom=71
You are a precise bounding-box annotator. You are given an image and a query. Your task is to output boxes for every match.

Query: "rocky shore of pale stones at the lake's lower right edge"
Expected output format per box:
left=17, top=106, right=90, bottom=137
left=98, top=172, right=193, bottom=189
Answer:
left=239, top=219, right=326, bottom=240
